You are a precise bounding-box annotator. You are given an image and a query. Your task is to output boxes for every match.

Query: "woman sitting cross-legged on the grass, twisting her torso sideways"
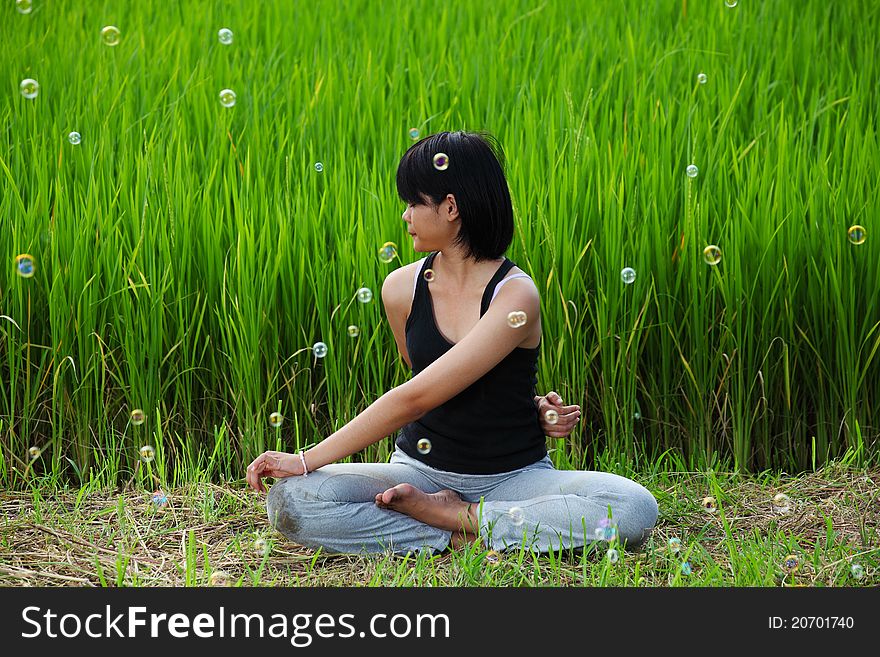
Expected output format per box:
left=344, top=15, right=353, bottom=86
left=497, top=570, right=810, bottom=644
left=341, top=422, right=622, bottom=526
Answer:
left=247, top=132, right=657, bottom=553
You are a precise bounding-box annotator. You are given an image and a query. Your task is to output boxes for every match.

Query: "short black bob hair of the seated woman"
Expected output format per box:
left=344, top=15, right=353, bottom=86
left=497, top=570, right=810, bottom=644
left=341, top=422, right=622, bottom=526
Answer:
left=397, top=132, right=513, bottom=262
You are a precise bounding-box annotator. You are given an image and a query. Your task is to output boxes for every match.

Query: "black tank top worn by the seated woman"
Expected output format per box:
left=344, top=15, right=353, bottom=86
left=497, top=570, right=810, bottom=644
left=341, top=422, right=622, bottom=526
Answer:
left=397, top=252, right=547, bottom=474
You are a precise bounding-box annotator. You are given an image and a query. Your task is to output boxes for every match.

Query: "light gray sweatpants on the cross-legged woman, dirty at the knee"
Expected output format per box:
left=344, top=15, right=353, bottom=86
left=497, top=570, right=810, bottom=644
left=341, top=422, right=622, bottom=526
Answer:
left=266, top=449, right=657, bottom=553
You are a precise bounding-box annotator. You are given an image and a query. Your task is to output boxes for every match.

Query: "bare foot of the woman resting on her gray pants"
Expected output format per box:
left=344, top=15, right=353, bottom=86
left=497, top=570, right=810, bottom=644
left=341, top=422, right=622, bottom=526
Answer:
left=376, top=484, right=477, bottom=534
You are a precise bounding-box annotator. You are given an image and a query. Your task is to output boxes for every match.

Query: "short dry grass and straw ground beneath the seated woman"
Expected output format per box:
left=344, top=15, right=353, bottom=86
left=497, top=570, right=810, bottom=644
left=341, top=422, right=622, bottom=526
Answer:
left=0, top=466, right=880, bottom=586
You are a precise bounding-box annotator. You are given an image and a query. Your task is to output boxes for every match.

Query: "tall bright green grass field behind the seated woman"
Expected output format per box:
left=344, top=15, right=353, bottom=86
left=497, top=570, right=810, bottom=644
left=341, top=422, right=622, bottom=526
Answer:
left=0, top=0, right=880, bottom=486
